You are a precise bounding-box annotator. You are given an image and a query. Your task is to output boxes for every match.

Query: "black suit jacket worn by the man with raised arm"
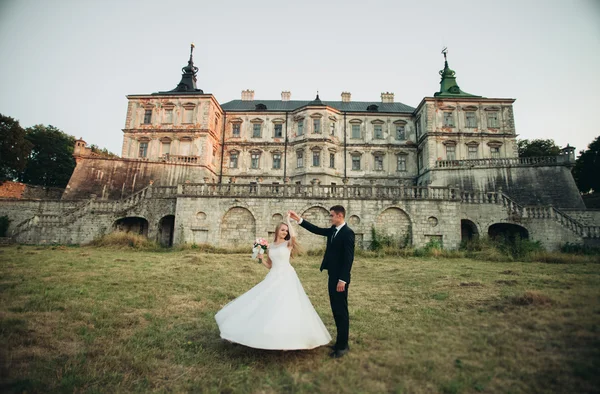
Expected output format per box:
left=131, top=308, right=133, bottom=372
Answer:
left=300, top=219, right=354, bottom=284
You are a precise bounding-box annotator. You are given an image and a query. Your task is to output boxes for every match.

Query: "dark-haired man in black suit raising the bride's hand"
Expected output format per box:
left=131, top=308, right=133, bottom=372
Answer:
left=290, top=205, right=354, bottom=358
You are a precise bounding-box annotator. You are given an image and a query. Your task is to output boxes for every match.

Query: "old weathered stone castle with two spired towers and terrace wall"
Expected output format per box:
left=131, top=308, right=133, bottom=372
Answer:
left=0, top=46, right=600, bottom=249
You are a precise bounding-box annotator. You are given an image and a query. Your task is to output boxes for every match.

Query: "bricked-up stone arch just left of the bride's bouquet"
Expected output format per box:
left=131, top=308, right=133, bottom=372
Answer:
left=219, top=206, right=256, bottom=248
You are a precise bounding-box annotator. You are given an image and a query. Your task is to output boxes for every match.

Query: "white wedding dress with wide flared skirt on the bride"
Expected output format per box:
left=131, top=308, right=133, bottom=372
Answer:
left=215, top=241, right=331, bottom=350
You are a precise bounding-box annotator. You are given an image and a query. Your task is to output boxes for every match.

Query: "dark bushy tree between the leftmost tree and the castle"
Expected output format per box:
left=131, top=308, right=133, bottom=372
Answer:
left=21, top=125, right=75, bottom=187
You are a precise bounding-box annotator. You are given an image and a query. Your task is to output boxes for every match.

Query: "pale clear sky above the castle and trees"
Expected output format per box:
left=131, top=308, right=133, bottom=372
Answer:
left=0, top=0, right=600, bottom=154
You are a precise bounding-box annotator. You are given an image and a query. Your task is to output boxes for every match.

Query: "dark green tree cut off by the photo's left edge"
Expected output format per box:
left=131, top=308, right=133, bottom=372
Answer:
left=0, top=114, right=33, bottom=182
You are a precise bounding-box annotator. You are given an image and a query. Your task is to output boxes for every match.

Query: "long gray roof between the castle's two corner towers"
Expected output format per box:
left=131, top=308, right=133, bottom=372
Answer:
left=221, top=100, right=415, bottom=113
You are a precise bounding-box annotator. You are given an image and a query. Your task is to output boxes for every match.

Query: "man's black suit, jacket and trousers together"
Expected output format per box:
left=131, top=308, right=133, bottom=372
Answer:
left=300, top=220, right=354, bottom=349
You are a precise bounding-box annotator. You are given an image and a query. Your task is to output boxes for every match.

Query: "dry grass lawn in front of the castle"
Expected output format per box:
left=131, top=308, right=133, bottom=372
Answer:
left=0, top=246, right=600, bottom=393
